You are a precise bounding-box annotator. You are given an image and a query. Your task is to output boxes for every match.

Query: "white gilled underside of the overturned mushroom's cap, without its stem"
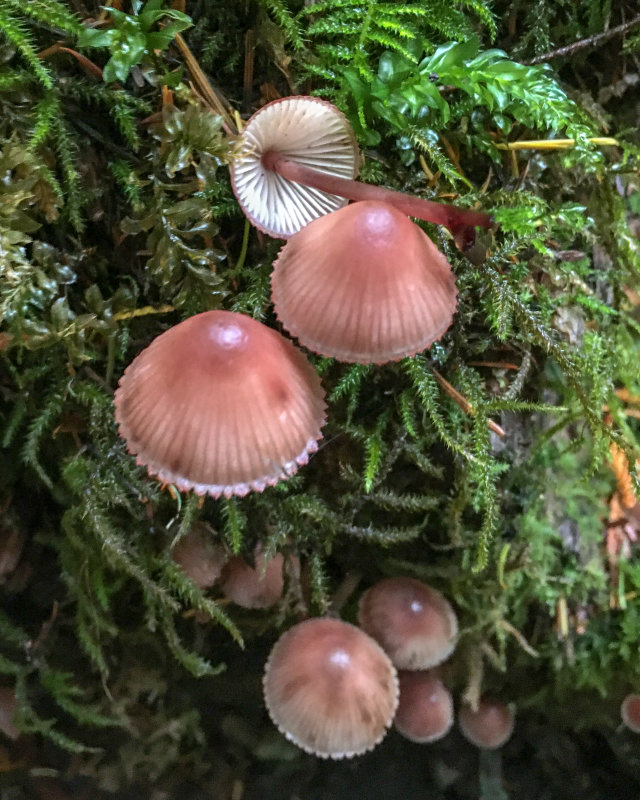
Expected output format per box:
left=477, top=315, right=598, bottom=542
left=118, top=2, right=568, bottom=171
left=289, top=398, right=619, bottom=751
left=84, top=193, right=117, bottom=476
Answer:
left=231, top=97, right=359, bottom=239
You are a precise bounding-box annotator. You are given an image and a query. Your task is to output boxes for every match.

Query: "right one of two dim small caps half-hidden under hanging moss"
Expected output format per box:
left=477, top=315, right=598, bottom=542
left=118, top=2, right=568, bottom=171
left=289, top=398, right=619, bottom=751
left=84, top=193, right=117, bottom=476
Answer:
left=222, top=546, right=284, bottom=608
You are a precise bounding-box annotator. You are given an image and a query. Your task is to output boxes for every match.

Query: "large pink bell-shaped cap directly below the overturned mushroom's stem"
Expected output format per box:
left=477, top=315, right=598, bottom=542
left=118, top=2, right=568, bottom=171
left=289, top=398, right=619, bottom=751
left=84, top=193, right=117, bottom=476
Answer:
left=271, top=201, right=457, bottom=364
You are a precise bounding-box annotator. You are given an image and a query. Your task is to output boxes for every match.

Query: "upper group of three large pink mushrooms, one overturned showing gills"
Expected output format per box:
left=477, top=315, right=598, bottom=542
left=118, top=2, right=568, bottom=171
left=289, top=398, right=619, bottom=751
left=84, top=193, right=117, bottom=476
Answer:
left=115, top=97, right=490, bottom=497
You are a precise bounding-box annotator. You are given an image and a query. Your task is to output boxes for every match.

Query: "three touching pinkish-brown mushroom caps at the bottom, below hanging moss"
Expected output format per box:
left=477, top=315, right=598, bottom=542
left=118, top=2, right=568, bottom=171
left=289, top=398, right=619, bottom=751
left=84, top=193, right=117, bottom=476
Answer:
left=264, top=578, right=480, bottom=758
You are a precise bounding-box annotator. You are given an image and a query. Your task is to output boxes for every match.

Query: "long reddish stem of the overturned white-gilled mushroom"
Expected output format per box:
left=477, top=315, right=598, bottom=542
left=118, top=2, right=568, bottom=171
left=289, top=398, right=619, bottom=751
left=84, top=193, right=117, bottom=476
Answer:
left=262, top=150, right=493, bottom=235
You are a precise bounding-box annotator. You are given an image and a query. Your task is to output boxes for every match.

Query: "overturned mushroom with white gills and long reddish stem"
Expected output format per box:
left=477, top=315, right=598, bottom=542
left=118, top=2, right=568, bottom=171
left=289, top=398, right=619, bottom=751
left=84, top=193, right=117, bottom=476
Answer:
left=231, top=96, right=492, bottom=247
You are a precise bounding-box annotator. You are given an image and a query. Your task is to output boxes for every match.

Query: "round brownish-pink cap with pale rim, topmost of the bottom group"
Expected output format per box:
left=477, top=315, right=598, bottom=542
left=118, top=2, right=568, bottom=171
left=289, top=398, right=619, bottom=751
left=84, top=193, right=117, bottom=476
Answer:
left=358, top=578, right=458, bottom=670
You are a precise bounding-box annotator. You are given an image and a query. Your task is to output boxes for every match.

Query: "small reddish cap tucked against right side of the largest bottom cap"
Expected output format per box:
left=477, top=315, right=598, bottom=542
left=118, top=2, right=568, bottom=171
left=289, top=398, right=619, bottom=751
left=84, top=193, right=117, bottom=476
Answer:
left=393, top=672, right=453, bottom=743
